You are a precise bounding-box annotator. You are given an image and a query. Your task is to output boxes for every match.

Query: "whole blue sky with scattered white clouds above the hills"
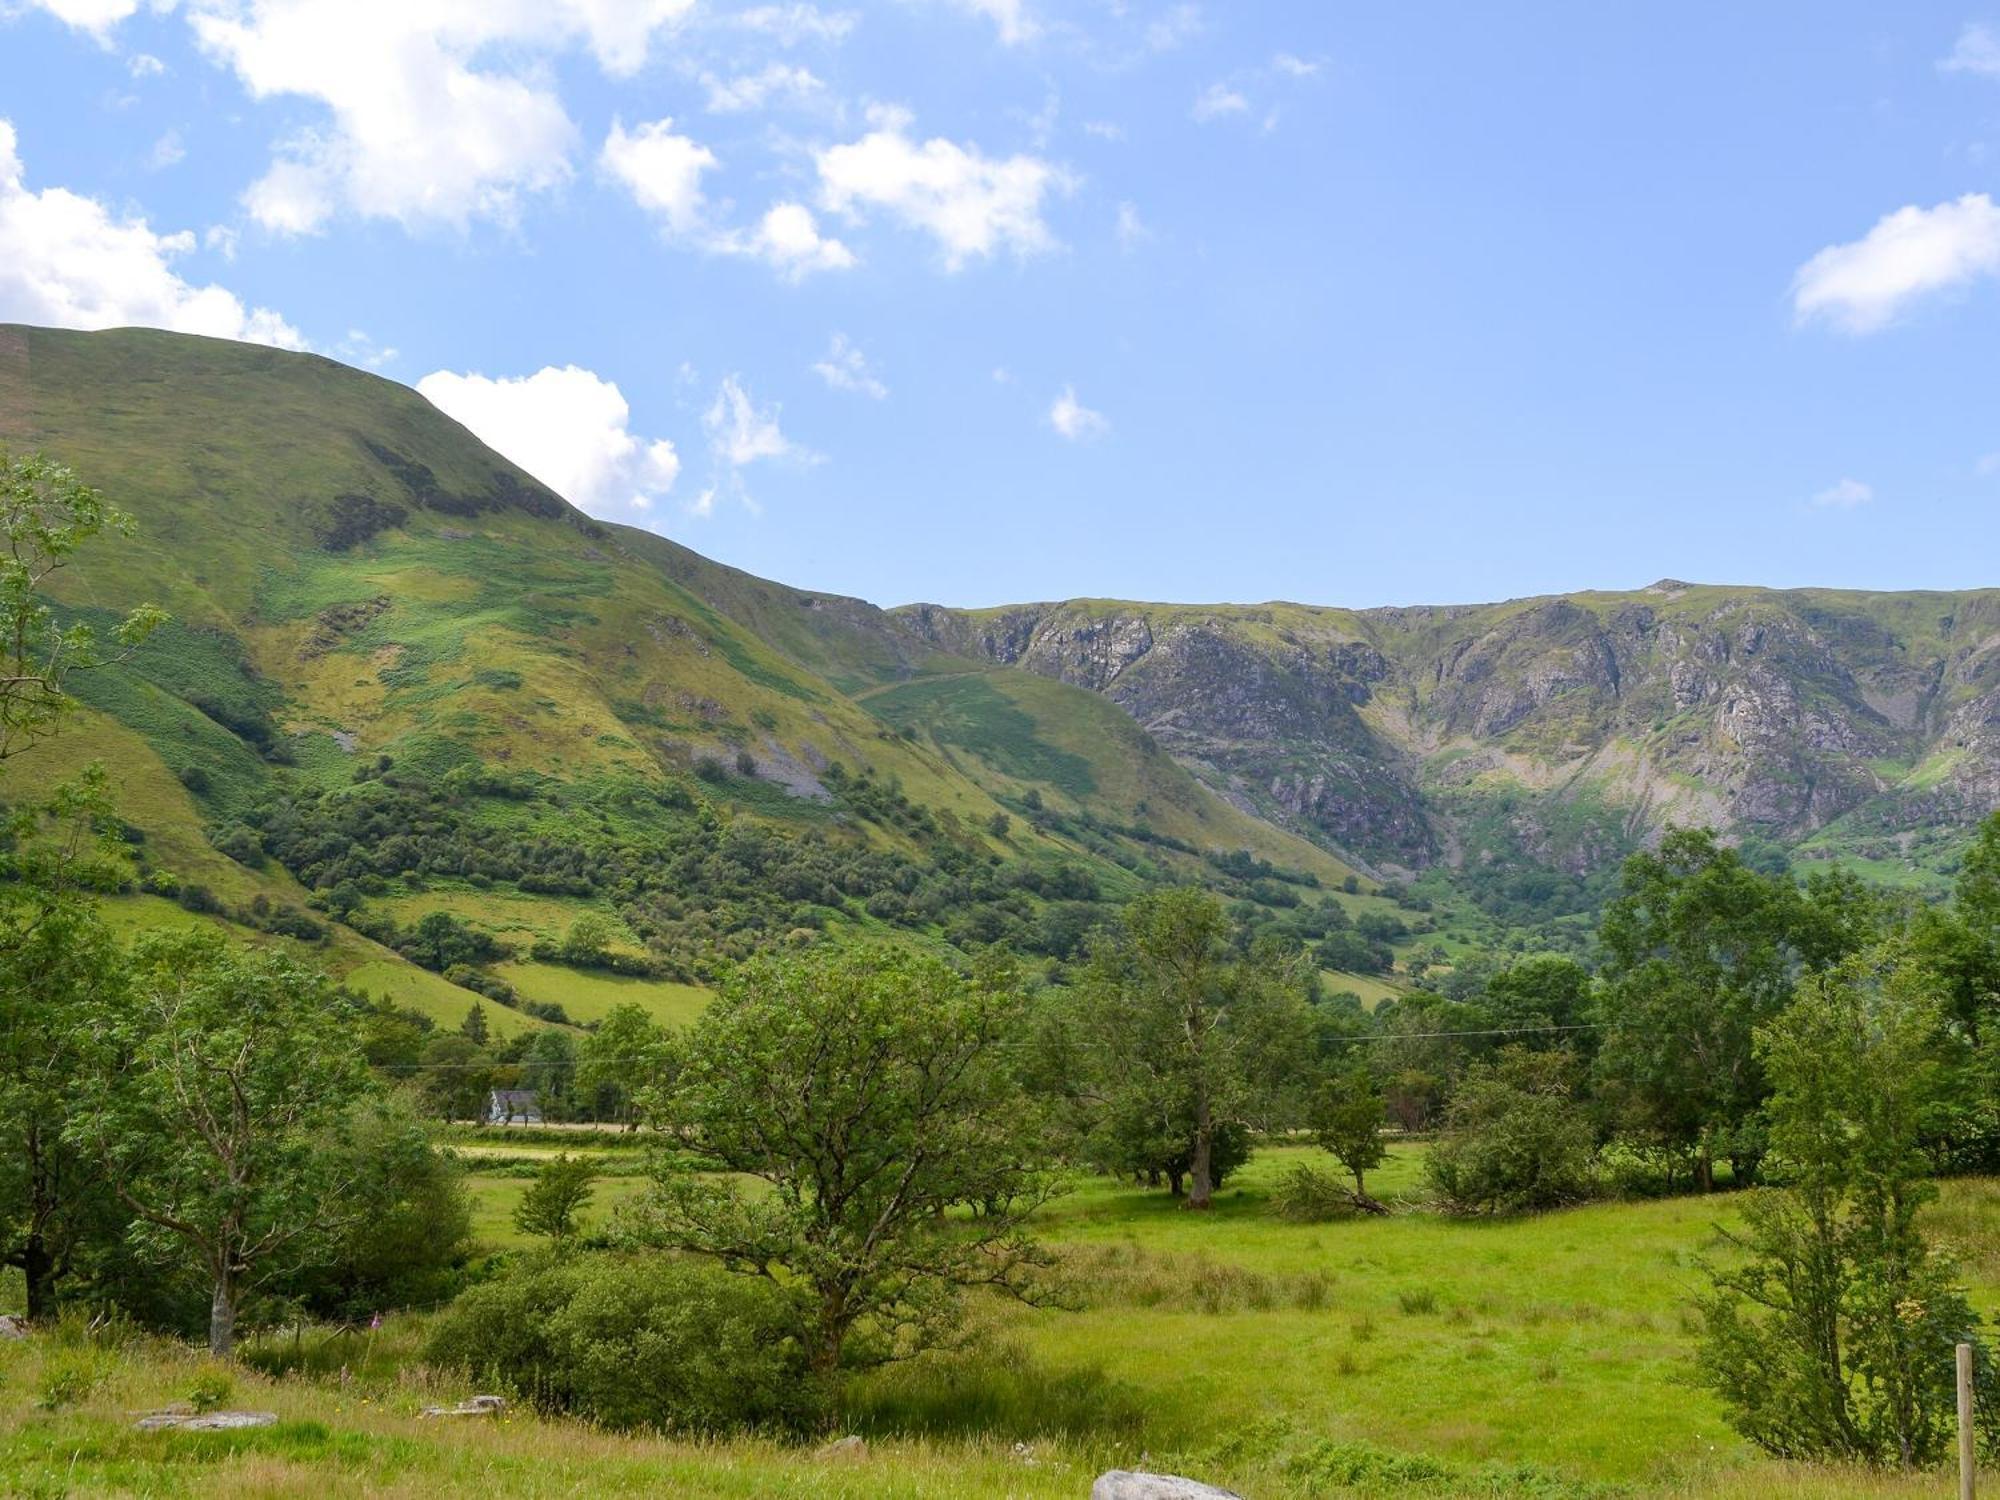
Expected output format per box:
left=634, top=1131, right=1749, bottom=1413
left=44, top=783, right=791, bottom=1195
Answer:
left=0, top=0, right=2000, bottom=606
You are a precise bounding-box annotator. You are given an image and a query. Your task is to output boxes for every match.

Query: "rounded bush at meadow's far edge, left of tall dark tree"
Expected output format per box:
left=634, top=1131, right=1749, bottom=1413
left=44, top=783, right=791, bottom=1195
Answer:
left=1424, top=1048, right=1598, bottom=1214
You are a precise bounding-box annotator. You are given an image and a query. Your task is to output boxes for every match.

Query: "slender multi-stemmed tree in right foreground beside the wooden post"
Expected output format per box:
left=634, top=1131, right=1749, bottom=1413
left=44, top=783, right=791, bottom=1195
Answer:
left=1700, top=948, right=1996, bottom=1466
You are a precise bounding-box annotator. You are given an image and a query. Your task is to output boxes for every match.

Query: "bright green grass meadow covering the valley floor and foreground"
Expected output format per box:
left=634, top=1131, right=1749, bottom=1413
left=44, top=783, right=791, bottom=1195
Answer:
left=0, top=1132, right=2000, bottom=1500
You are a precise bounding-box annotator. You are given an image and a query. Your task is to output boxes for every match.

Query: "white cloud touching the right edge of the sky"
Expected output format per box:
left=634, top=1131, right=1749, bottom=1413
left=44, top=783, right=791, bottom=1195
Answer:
left=1792, top=192, right=2000, bottom=334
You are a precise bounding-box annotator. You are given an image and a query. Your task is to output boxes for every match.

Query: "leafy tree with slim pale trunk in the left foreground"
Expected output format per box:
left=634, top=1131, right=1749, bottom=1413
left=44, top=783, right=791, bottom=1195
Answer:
left=76, top=932, right=370, bottom=1354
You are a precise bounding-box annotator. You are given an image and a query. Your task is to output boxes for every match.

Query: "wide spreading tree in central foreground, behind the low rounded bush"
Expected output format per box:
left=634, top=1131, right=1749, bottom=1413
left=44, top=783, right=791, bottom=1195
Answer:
left=640, top=950, right=1052, bottom=1378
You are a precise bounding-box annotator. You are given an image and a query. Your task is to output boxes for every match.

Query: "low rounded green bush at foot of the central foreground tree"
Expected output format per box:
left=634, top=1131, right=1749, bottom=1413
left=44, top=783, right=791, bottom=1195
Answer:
left=426, top=1256, right=824, bottom=1434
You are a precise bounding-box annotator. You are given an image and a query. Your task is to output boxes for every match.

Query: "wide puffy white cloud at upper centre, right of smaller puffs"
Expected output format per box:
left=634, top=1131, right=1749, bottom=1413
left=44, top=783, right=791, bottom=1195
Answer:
left=814, top=106, right=1074, bottom=270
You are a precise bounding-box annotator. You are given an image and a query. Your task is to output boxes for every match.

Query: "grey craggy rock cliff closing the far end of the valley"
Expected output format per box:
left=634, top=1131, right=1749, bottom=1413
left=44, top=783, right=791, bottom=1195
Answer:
left=896, top=580, right=2000, bottom=868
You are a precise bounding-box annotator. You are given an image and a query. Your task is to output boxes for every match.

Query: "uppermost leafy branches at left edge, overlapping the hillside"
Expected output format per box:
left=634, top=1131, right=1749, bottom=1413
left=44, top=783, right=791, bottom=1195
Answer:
left=0, top=448, right=166, bottom=760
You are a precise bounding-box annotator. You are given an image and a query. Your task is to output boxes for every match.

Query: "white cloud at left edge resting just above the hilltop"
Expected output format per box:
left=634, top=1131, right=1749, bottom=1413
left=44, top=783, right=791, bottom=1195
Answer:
left=0, top=120, right=306, bottom=348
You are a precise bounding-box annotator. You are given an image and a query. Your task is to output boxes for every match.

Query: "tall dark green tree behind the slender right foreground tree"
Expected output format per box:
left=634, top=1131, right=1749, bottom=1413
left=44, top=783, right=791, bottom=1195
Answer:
left=1596, top=830, right=1842, bottom=1188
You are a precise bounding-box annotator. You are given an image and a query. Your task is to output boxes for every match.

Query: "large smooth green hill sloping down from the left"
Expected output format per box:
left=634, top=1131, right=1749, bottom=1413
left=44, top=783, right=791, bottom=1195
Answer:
left=0, top=328, right=1348, bottom=1024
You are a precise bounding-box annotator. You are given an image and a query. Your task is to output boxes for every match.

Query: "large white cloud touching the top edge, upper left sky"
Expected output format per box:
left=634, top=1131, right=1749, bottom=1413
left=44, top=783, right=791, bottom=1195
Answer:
left=188, top=0, right=694, bottom=234
